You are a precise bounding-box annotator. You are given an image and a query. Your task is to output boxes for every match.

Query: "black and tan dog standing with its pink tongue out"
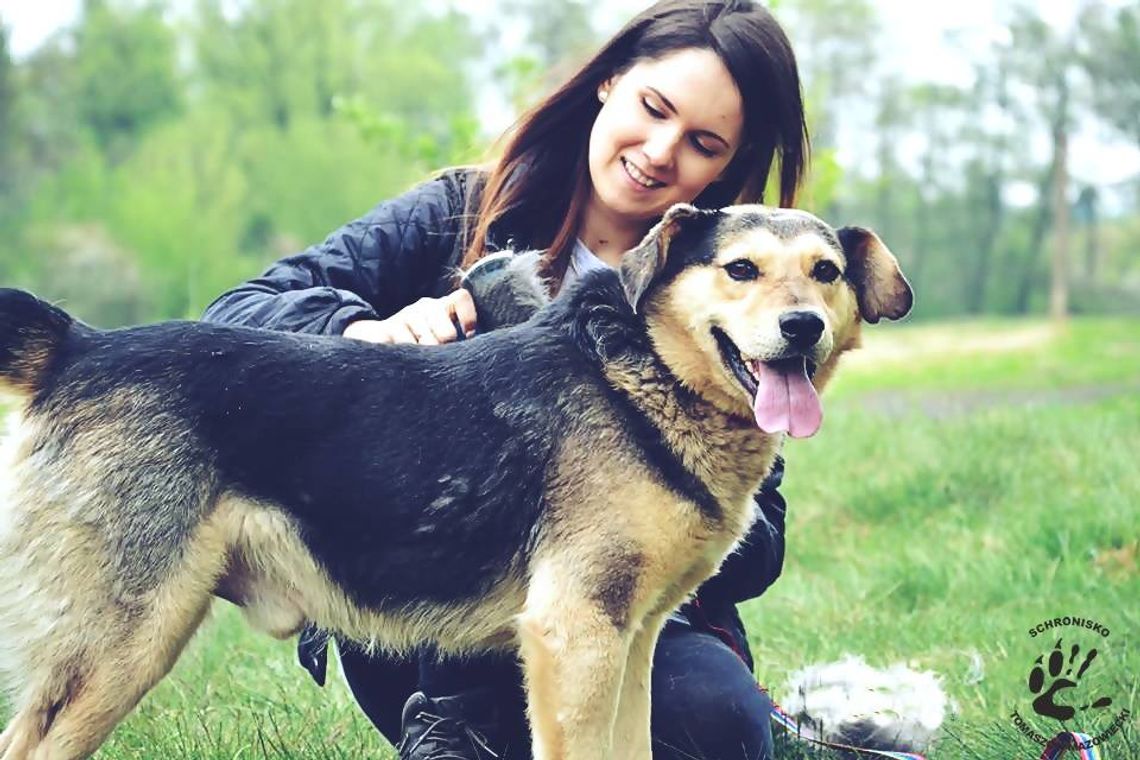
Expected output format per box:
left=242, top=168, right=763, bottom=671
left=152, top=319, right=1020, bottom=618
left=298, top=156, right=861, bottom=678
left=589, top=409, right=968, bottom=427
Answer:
left=0, top=206, right=911, bottom=760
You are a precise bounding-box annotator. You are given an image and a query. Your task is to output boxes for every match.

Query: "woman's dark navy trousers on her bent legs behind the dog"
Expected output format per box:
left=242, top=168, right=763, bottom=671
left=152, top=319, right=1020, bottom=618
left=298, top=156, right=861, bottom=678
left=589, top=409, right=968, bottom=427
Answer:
left=332, top=620, right=772, bottom=760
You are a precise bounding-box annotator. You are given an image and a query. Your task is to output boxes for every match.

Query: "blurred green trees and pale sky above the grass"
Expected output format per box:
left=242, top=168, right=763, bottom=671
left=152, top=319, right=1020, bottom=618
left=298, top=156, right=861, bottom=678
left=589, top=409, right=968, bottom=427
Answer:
left=0, top=0, right=1140, bottom=325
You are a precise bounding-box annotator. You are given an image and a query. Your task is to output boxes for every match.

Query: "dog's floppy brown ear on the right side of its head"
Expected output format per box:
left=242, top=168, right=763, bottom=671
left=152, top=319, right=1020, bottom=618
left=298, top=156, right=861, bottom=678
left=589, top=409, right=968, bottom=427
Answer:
left=836, top=227, right=914, bottom=325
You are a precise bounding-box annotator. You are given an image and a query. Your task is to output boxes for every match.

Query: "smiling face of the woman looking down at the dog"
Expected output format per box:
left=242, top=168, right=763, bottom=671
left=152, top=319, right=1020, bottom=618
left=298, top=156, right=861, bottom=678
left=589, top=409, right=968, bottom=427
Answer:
left=589, top=48, right=744, bottom=222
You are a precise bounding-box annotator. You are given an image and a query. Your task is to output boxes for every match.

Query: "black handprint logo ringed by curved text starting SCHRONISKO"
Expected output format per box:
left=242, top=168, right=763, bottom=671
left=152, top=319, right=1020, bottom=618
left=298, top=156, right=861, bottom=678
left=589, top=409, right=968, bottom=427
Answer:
left=1010, top=616, right=1131, bottom=757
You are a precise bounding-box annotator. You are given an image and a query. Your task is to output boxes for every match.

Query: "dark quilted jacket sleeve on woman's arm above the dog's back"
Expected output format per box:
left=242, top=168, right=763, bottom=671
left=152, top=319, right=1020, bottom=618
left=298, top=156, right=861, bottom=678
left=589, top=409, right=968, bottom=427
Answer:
left=203, top=172, right=464, bottom=335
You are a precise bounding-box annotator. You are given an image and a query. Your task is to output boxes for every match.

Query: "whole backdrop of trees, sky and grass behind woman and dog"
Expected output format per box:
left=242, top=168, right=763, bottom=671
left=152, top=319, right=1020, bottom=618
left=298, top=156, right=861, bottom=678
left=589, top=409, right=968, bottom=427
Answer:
left=0, top=0, right=1140, bottom=760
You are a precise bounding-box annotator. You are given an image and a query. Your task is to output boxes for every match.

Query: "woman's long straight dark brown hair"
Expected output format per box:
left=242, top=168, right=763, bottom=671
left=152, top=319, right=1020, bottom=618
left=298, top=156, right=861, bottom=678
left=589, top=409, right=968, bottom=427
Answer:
left=463, top=0, right=808, bottom=280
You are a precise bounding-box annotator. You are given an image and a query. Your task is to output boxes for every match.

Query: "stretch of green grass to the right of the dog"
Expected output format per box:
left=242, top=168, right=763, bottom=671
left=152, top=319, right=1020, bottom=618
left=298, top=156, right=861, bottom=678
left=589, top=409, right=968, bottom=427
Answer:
left=743, top=314, right=1140, bottom=758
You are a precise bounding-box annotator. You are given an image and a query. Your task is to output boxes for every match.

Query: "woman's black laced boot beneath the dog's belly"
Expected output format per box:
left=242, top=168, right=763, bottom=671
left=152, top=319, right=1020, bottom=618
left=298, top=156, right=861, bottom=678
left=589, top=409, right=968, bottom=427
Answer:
left=397, top=689, right=499, bottom=760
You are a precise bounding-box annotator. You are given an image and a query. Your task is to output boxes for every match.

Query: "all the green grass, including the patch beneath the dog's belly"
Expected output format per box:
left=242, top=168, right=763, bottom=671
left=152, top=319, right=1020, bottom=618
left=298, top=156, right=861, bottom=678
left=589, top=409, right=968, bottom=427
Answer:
left=2, top=320, right=1140, bottom=760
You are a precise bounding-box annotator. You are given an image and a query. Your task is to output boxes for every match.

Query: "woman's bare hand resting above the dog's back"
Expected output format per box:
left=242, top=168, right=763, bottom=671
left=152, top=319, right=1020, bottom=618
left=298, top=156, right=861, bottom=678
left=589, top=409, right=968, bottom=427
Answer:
left=344, top=288, right=475, bottom=345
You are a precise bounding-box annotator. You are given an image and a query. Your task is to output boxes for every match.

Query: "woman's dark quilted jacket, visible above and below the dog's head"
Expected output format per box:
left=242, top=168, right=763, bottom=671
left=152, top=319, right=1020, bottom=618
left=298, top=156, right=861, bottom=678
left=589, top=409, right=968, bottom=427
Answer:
left=204, top=169, right=784, bottom=635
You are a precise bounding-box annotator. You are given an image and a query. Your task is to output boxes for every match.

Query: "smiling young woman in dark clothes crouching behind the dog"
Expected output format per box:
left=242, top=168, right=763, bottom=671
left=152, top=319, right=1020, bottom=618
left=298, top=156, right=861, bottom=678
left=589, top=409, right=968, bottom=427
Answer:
left=205, top=0, right=807, bottom=759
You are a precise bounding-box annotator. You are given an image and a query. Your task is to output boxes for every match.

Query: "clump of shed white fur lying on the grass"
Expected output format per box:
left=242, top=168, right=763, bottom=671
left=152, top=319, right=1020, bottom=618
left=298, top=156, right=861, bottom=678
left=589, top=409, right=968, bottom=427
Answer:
left=782, top=655, right=955, bottom=752
